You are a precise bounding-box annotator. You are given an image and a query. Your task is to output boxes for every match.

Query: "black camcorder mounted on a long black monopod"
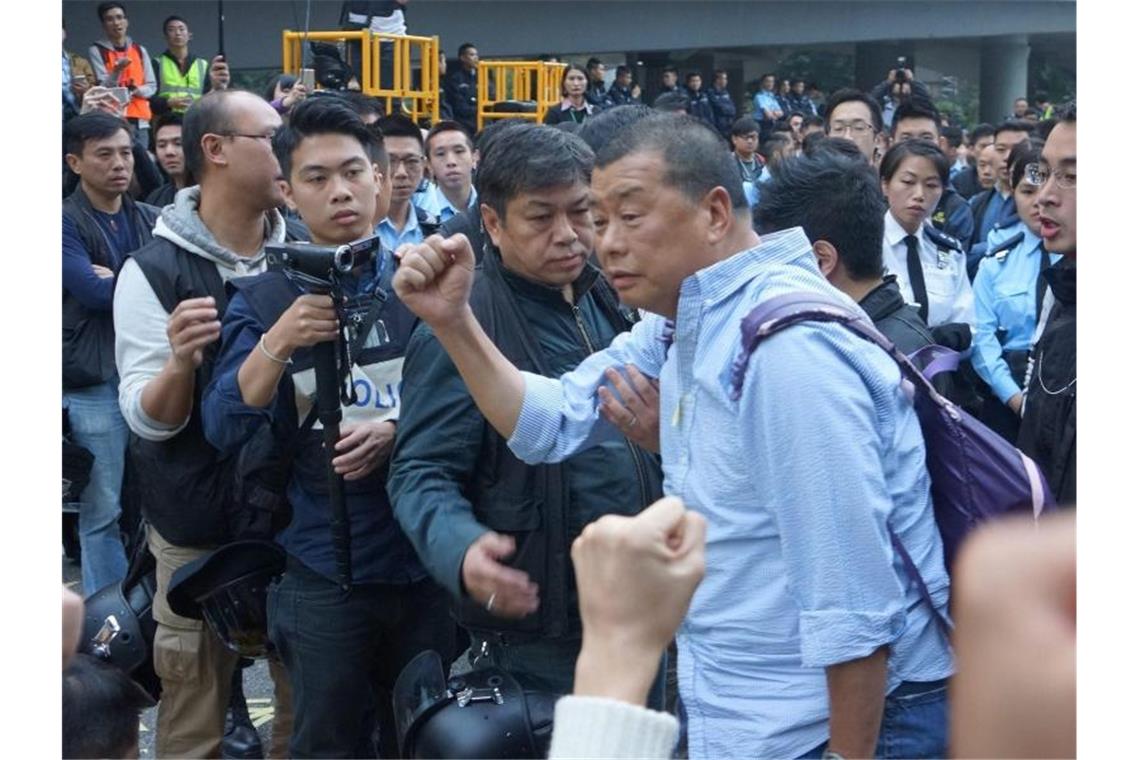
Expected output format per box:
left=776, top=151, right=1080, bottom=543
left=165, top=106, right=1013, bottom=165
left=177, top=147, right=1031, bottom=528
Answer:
left=266, top=237, right=380, bottom=591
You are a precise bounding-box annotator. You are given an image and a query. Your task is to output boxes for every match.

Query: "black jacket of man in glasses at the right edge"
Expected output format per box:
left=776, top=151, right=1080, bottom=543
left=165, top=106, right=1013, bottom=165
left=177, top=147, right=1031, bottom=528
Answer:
left=1017, top=259, right=1076, bottom=505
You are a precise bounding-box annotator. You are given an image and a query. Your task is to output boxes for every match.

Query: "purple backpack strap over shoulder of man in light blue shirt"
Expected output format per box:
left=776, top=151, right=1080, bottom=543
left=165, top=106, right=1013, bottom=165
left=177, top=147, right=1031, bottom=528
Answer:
left=732, top=292, right=958, bottom=636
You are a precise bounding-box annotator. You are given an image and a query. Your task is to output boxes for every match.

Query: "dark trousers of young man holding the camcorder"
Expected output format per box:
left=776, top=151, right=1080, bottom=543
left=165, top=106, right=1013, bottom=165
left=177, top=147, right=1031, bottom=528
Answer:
left=268, top=561, right=455, bottom=758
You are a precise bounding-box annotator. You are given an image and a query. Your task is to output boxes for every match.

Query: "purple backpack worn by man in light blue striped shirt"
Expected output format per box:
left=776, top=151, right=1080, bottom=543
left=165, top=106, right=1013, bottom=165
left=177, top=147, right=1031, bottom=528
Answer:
left=732, top=292, right=1056, bottom=622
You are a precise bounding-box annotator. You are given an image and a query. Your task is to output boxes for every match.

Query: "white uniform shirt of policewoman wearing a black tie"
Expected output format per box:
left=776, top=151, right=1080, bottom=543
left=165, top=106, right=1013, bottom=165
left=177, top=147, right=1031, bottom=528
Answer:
left=882, top=210, right=974, bottom=327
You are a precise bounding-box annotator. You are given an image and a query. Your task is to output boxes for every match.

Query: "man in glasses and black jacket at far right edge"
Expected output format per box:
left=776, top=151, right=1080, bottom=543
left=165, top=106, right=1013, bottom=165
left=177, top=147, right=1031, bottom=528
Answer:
left=1017, top=104, right=1076, bottom=504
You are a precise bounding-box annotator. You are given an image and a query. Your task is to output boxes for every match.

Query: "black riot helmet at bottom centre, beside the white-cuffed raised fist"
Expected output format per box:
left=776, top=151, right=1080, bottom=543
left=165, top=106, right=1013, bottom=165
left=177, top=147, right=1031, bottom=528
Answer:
left=392, top=651, right=557, bottom=758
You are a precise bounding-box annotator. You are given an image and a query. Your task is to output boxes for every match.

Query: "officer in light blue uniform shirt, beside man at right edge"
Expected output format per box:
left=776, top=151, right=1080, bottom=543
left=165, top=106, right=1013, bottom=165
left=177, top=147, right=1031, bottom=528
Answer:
left=971, top=141, right=1061, bottom=442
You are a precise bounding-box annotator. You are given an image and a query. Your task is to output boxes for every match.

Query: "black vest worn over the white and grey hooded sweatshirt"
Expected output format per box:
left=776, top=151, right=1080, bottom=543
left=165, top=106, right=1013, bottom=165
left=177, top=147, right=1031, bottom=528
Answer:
left=129, top=238, right=234, bottom=548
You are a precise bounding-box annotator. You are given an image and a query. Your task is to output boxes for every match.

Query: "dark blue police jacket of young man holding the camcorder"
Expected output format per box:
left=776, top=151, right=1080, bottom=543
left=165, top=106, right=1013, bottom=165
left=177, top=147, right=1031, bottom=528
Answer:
left=202, top=258, right=426, bottom=583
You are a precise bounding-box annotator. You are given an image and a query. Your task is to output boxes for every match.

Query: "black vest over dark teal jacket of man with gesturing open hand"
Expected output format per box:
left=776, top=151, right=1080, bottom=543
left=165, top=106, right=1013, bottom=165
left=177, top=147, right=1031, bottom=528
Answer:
left=455, top=253, right=630, bottom=640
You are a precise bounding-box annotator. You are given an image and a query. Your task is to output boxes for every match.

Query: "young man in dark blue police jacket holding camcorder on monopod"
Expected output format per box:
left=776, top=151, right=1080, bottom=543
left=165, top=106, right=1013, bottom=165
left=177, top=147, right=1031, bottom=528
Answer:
left=203, top=97, right=454, bottom=758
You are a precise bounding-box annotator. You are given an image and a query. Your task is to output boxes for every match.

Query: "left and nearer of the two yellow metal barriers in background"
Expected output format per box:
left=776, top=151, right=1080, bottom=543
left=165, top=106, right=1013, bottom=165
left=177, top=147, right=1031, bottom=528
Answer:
left=282, top=30, right=439, bottom=124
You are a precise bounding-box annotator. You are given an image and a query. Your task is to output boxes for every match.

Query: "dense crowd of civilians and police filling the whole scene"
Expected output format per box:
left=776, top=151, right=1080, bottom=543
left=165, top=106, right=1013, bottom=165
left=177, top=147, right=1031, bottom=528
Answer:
left=63, top=0, right=1076, bottom=758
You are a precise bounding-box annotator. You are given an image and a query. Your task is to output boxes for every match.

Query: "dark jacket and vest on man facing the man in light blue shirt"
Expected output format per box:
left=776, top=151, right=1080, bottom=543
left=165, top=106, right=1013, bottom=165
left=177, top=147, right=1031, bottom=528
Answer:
left=388, top=248, right=661, bottom=639
